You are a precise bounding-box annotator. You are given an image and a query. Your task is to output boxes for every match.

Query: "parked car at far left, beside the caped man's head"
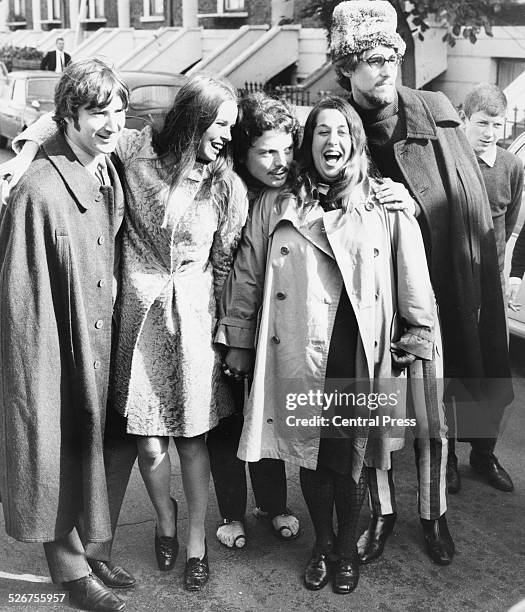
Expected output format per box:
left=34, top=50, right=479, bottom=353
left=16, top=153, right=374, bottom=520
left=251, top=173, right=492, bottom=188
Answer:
left=0, top=70, right=59, bottom=147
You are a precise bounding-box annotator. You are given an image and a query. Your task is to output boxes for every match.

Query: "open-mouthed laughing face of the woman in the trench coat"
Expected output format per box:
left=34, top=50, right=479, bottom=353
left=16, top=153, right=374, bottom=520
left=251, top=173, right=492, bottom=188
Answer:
left=312, top=108, right=352, bottom=183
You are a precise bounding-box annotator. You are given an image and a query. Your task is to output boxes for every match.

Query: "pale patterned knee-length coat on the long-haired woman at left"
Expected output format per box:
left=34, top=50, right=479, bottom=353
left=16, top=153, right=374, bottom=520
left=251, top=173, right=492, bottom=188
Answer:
left=113, top=128, right=248, bottom=437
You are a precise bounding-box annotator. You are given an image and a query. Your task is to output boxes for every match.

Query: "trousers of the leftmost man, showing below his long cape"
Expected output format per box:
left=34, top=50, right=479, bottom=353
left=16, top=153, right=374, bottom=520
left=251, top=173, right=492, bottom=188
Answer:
left=44, top=408, right=137, bottom=583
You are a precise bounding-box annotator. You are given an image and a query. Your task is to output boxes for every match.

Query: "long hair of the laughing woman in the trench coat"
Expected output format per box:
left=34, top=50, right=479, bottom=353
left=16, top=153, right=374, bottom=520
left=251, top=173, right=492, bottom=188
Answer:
left=289, top=96, right=370, bottom=211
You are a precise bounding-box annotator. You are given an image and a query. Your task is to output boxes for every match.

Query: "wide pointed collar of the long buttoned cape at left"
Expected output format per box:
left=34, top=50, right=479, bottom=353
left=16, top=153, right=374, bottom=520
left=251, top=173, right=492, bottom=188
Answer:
left=42, top=133, right=100, bottom=210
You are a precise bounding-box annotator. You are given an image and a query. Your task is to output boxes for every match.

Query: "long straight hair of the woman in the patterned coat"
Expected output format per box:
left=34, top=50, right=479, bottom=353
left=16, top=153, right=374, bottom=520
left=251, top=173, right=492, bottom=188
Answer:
left=152, top=74, right=237, bottom=191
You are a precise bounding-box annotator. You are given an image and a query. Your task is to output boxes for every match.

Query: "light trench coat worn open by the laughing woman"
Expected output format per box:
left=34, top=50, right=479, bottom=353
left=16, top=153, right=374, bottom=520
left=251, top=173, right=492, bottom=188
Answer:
left=216, top=186, right=436, bottom=480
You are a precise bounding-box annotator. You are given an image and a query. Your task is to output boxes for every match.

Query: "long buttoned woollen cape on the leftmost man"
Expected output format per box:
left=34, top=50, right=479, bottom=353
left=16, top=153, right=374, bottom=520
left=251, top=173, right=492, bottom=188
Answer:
left=0, top=135, right=123, bottom=542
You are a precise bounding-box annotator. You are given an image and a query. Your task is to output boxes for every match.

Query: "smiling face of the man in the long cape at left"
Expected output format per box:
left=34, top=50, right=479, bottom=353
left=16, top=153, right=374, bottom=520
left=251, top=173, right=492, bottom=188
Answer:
left=65, top=96, right=126, bottom=157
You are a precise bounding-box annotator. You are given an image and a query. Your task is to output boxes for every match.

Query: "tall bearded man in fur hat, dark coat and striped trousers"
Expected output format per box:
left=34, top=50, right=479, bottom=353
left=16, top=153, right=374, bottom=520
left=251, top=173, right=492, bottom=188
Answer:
left=330, top=0, right=512, bottom=565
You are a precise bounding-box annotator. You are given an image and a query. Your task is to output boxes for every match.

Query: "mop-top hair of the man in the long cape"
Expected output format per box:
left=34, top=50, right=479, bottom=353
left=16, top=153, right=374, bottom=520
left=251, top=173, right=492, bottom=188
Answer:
left=53, top=59, right=129, bottom=131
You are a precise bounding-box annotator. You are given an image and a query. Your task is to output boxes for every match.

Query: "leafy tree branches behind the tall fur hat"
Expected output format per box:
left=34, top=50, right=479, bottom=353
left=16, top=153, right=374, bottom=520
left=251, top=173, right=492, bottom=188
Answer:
left=301, top=0, right=505, bottom=87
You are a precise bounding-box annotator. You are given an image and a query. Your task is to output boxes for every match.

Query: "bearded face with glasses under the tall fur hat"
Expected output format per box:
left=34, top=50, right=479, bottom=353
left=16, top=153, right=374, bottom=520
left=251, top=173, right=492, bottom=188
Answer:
left=343, top=46, right=398, bottom=109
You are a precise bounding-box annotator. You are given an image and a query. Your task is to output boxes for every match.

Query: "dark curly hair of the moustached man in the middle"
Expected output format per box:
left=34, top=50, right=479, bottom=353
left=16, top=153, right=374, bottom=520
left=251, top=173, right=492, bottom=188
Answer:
left=232, top=92, right=300, bottom=182
